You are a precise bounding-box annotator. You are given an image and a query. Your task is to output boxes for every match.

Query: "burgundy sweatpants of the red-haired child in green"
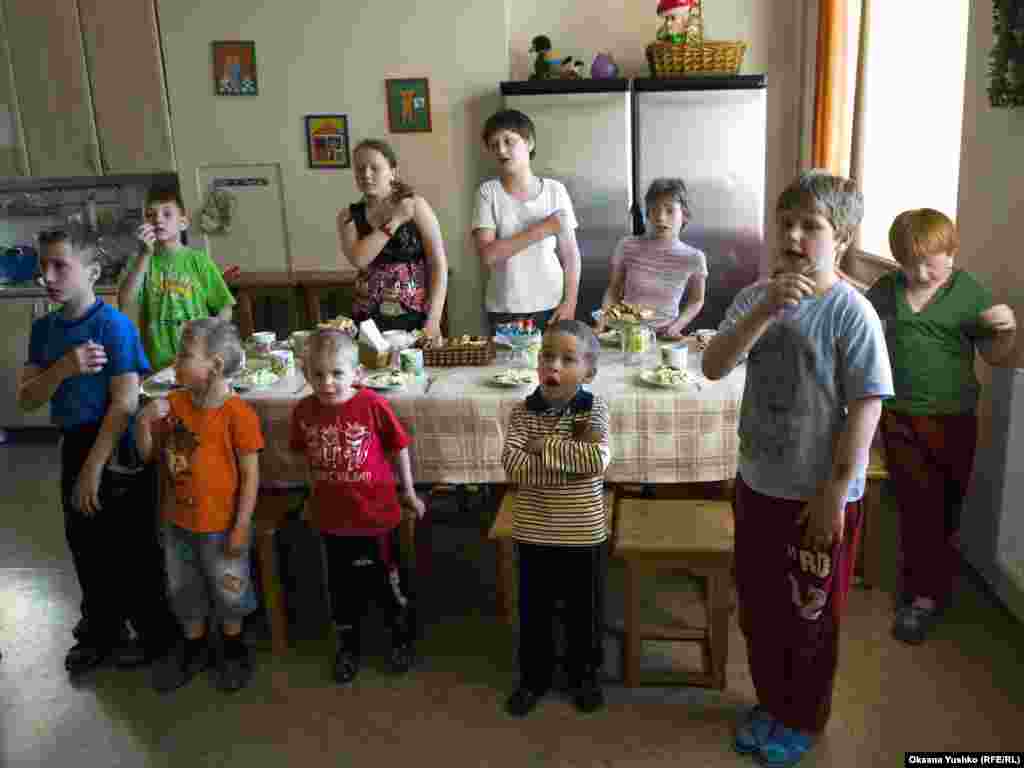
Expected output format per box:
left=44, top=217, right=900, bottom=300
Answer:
left=882, top=411, right=978, bottom=605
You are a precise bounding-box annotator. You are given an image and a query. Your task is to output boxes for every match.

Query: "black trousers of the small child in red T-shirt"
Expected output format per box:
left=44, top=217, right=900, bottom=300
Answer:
left=324, top=528, right=413, bottom=631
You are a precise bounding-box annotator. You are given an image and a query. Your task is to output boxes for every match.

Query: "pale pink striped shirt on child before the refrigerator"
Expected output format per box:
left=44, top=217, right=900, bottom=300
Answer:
left=611, top=236, right=708, bottom=326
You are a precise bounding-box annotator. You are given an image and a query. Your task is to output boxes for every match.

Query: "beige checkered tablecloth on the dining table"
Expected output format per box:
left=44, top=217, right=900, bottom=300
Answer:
left=245, top=353, right=745, bottom=485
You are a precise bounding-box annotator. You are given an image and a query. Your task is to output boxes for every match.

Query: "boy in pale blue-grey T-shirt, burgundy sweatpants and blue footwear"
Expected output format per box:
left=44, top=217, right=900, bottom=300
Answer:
left=703, top=171, right=893, bottom=766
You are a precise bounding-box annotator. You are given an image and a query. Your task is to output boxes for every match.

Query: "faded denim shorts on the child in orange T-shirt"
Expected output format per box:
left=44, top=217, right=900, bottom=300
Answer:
left=164, top=523, right=257, bottom=624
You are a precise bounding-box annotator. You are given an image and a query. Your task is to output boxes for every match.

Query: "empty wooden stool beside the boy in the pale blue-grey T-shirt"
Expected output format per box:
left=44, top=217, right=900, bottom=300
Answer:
left=615, top=499, right=733, bottom=690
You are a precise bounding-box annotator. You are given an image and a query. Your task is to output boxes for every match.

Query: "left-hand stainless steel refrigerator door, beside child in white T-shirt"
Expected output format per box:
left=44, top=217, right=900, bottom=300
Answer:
left=505, top=91, right=633, bottom=321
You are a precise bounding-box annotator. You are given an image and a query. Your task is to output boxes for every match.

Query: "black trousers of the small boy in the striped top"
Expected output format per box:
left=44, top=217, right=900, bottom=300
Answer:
left=516, top=542, right=606, bottom=693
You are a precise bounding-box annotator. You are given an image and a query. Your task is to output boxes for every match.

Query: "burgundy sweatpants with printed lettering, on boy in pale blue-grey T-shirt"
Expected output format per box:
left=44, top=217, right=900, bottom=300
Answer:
left=732, top=476, right=862, bottom=732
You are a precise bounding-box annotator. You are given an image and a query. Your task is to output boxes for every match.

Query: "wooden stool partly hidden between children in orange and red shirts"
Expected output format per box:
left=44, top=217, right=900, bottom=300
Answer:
left=253, top=489, right=305, bottom=654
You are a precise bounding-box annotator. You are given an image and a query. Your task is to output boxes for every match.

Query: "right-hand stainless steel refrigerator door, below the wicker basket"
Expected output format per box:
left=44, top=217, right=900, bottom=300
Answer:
left=634, top=88, right=768, bottom=329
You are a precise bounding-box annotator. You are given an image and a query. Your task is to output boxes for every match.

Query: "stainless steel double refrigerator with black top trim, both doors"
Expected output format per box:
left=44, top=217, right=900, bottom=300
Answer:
left=501, top=75, right=767, bottom=329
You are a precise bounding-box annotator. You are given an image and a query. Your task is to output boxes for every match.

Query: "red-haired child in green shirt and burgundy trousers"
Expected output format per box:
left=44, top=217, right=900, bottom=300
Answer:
left=867, top=208, right=1017, bottom=644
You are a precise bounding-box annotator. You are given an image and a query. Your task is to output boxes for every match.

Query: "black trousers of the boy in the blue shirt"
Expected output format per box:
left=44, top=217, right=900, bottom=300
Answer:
left=60, top=425, right=180, bottom=654
